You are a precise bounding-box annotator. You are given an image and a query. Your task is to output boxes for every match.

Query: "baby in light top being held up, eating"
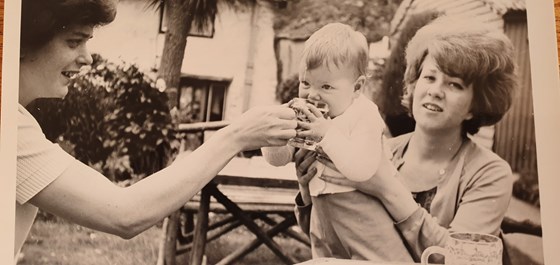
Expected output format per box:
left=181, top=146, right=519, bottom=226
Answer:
left=262, top=23, right=410, bottom=261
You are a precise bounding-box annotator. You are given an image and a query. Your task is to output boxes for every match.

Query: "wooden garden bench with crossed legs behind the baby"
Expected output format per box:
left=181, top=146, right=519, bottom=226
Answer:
left=165, top=121, right=310, bottom=264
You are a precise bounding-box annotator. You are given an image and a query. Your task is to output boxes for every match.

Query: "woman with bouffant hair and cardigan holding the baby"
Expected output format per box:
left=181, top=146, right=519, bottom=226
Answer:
left=296, top=17, right=516, bottom=261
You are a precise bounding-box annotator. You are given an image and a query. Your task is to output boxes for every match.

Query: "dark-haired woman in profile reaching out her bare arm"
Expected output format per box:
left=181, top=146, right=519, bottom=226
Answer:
left=14, top=0, right=297, bottom=254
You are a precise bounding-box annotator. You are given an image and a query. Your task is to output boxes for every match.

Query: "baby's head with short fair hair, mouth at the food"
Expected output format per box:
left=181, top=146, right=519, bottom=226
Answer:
left=298, top=23, right=368, bottom=117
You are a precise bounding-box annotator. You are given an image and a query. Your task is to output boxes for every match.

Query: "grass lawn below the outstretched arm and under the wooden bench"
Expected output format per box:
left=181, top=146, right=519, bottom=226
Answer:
left=18, top=217, right=311, bottom=265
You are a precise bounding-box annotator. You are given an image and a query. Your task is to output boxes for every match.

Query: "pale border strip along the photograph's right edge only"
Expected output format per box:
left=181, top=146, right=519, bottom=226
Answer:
left=527, top=0, right=560, bottom=265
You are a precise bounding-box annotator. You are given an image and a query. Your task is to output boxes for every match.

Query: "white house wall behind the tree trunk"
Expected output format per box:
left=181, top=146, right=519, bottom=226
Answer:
left=90, top=0, right=277, bottom=119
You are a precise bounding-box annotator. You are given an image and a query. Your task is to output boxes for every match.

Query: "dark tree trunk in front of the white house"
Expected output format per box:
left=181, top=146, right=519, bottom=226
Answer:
left=158, top=0, right=196, bottom=109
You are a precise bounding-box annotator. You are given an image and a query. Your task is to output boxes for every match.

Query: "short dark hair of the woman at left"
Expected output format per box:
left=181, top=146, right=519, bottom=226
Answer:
left=20, top=0, right=117, bottom=50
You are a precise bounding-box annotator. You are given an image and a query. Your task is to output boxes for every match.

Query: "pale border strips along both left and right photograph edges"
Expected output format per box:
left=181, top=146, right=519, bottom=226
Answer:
left=0, top=0, right=560, bottom=265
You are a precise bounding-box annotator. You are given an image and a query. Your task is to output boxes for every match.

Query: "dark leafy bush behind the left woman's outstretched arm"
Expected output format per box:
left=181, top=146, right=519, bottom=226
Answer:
left=28, top=55, right=179, bottom=181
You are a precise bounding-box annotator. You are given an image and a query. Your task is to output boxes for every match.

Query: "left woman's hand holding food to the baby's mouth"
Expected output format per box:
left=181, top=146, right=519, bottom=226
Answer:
left=224, top=105, right=297, bottom=151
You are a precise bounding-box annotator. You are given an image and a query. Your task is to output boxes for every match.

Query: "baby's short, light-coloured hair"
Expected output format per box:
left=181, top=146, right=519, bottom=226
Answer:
left=300, top=23, right=368, bottom=76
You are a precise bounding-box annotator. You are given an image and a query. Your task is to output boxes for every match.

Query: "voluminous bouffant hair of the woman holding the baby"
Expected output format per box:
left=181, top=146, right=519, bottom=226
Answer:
left=403, top=16, right=517, bottom=135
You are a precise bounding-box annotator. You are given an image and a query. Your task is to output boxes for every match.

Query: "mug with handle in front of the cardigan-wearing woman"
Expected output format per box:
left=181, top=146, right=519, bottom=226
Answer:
left=421, top=232, right=503, bottom=265
